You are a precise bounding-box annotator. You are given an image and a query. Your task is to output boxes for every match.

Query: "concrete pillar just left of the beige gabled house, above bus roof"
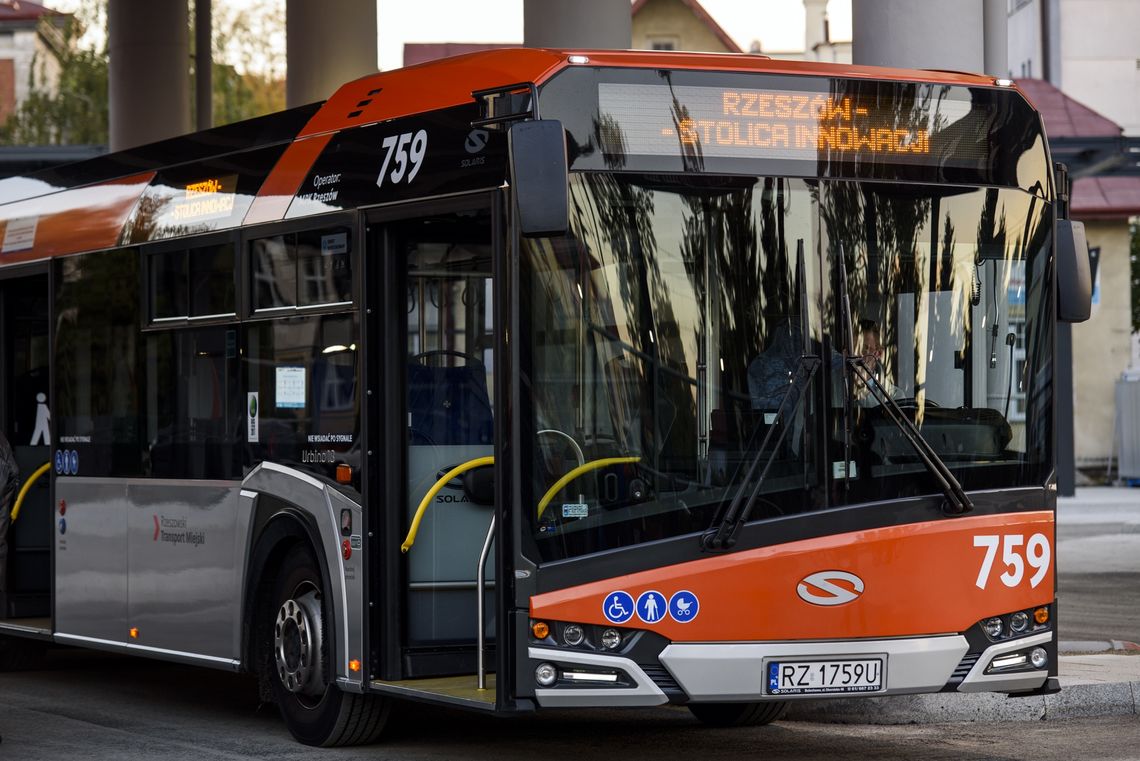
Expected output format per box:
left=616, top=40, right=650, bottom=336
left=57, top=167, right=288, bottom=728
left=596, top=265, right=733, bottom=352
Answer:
left=522, top=0, right=633, bottom=50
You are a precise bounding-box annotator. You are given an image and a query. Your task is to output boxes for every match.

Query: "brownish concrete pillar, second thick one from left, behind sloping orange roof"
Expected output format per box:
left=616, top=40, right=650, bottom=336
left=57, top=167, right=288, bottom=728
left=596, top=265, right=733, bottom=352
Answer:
left=285, top=0, right=377, bottom=108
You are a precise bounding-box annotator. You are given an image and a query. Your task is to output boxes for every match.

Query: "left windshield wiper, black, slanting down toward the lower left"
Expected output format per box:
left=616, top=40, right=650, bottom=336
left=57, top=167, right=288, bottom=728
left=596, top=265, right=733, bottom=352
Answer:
left=701, top=238, right=820, bottom=551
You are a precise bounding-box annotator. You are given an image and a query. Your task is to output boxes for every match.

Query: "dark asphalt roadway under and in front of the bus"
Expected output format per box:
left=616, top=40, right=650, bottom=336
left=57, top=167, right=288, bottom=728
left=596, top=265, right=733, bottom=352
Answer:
left=0, top=652, right=1140, bottom=761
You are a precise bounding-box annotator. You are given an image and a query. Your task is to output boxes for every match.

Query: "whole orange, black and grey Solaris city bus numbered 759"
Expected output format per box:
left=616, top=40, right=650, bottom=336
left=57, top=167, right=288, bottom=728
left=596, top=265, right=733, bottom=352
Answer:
left=0, top=49, right=1089, bottom=745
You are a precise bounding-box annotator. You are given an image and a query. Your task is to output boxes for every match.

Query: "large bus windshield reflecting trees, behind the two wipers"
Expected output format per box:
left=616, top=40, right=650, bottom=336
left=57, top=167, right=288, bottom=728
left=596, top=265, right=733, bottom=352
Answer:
left=520, top=172, right=1052, bottom=560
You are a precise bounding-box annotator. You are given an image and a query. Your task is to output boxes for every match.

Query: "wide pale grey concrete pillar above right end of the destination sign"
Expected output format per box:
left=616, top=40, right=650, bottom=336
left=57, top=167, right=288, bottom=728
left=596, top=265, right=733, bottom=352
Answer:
left=852, top=0, right=985, bottom=72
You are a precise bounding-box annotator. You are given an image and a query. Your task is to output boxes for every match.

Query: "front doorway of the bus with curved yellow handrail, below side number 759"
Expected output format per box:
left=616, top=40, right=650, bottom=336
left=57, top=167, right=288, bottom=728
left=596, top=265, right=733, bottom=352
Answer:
left=369, top=196, right=495, bottom=683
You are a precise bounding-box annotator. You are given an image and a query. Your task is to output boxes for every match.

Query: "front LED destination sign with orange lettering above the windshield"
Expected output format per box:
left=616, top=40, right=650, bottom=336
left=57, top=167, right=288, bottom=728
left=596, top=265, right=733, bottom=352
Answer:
left=599, top=83, right=976, bottom=163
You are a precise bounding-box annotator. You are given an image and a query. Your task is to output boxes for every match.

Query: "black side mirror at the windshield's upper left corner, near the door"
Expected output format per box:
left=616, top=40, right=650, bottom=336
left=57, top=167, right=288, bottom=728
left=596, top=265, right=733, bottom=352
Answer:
left=506, top=120, right=570, bottom=238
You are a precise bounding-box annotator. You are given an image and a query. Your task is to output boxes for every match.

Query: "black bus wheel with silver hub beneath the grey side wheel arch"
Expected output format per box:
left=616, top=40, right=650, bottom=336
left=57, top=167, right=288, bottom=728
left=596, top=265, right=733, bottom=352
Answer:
left=267, top=546, right=390, bottom=747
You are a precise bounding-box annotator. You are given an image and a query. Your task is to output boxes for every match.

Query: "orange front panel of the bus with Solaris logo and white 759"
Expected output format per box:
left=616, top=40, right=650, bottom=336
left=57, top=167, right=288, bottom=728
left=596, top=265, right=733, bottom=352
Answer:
left=530, top=510, right=1056, bottom=641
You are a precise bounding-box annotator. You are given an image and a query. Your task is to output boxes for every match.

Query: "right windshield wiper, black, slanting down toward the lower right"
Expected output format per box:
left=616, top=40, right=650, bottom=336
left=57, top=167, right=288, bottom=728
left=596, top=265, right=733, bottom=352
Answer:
left=839, top=246, right=974, bottom=515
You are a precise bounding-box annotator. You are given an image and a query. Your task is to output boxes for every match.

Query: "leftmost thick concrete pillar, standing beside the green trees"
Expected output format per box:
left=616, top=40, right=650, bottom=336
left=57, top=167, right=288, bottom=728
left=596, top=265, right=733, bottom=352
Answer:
left=107, top=0, right=190, bottom=150
